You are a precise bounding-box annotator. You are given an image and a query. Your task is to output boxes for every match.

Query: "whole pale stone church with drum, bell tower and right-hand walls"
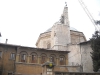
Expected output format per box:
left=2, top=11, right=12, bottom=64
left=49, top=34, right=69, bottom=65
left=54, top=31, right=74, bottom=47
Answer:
left=36, top=6, right=93, bottom=72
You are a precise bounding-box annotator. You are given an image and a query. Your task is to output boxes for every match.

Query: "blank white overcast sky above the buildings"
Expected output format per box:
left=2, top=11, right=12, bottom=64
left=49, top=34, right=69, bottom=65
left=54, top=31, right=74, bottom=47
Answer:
left=0, top=0, right=100, bottom=47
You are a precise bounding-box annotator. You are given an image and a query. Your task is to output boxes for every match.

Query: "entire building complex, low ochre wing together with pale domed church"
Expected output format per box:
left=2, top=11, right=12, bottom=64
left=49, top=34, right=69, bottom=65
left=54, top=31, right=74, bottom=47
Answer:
left=0, top=6, right=93, bottom=75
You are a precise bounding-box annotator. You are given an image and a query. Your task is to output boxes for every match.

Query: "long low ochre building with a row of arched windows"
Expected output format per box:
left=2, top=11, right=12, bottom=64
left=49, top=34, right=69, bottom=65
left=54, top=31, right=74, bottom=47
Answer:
left=0, top=43, right=80, bottom=75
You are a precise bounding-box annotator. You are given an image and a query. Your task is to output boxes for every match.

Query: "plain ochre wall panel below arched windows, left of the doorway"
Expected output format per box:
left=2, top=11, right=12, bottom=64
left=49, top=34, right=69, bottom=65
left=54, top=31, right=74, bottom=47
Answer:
left=16, top=64, right=42, bottom=74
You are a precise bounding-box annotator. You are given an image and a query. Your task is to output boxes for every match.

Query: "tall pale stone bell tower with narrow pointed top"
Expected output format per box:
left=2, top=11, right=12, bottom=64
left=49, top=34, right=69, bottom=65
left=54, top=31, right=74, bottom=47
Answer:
left=51, top=5, right=71, bottom=50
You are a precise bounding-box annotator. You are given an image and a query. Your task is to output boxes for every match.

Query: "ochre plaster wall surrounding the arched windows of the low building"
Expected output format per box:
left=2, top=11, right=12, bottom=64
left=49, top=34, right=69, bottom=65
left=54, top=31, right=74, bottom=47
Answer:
left=0, top=45, right=68, bottom=75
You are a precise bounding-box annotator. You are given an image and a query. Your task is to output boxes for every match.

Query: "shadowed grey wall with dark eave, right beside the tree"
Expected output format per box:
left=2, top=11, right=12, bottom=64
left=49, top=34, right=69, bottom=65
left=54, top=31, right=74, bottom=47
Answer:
left=80, top=42, right=93, bottom=72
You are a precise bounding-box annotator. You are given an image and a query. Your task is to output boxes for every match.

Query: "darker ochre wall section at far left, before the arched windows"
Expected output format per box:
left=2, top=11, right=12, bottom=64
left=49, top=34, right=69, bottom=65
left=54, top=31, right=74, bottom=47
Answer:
left=0, top=46, right=16, bottom=75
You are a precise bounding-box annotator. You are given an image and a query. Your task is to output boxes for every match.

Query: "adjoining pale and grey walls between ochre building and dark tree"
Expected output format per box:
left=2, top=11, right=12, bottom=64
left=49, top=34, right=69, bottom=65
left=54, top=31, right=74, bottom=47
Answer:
left=68, top=42, right=93, bottom=72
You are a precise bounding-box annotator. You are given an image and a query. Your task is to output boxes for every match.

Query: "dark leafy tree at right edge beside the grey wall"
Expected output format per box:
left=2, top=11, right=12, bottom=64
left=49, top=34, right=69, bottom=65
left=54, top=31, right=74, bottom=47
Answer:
left=90, top=31, right=100, bottom=72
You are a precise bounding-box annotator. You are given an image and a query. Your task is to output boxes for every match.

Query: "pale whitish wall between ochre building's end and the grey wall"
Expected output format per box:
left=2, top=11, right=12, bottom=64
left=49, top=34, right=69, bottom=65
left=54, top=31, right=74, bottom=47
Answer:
left=68, top=44, right=81, bottom=66
